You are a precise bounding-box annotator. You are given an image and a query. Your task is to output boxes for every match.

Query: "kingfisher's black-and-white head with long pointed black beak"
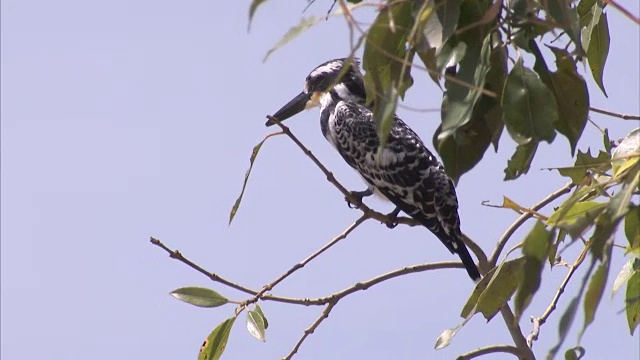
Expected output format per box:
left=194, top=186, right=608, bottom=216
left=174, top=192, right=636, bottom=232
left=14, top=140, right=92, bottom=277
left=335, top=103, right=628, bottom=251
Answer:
left=265, top=58, right=366, bottom=126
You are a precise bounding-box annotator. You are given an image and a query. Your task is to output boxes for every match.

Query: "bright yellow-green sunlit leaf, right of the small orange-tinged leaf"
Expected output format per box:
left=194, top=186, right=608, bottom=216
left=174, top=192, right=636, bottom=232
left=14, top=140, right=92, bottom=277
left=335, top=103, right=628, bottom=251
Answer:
left=547, top=201, right=607, bottom=238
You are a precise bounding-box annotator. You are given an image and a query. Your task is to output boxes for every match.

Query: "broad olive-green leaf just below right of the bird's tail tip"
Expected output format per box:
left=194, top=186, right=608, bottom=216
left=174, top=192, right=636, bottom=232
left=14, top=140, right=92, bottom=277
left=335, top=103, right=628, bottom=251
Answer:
left=460, top=258, right=524, bottom=321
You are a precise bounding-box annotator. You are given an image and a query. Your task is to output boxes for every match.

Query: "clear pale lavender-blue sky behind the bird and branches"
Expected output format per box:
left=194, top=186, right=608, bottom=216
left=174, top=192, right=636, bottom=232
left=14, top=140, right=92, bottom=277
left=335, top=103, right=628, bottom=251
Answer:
left=0, top=0, right=640, bottom=360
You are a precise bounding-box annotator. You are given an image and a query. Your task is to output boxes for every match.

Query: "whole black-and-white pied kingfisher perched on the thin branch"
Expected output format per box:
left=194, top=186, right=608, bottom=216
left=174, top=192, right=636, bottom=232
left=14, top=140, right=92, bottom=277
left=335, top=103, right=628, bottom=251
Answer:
left=266, top=59, right=480, bottom=281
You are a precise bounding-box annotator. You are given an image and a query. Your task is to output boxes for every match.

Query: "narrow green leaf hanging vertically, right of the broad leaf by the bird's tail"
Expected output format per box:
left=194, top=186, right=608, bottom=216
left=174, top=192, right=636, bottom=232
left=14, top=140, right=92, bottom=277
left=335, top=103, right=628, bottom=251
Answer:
left=514, top=221, right=554, bottom=319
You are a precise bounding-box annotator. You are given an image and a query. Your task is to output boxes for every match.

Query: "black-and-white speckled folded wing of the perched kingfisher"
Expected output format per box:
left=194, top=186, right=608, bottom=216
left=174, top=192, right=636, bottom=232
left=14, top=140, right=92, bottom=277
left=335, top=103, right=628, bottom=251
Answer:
left=336, top=103, right=460, bottom=252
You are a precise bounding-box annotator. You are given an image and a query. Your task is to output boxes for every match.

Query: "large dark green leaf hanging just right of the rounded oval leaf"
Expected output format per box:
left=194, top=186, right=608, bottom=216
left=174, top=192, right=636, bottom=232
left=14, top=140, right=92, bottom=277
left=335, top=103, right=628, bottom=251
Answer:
left=542, top=47, right=589, bottom=156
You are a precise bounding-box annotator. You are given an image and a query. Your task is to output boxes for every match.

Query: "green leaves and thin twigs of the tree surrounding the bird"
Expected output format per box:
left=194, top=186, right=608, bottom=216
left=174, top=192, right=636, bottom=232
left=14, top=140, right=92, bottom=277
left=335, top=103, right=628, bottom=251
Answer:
left=152, top=0, right=640, bottom=359
